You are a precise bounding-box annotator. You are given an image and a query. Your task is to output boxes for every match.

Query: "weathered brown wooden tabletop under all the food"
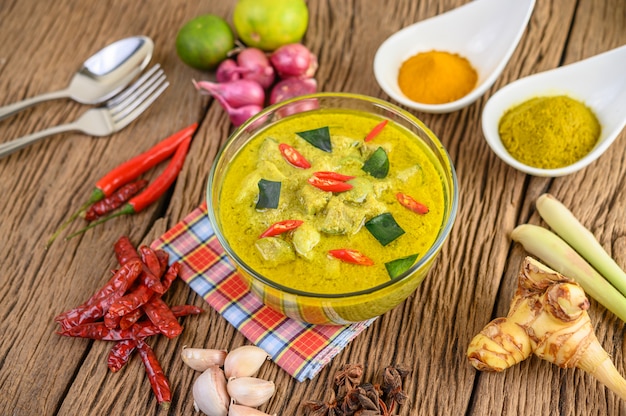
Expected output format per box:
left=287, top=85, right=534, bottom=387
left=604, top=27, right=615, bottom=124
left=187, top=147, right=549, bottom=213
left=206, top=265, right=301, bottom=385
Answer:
left=0, top=0, right=626, bottom=416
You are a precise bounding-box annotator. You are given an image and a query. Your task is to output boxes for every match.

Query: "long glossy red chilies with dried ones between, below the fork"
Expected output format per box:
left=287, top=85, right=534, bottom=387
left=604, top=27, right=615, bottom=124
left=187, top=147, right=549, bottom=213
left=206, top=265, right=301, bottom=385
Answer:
left=46, top=123, right=198, bottom=247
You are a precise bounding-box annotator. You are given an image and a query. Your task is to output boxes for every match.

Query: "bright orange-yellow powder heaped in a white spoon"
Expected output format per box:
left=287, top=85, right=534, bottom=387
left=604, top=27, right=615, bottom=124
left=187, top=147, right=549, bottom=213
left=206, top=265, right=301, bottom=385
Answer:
left=398, top=50, right=478, bottom=104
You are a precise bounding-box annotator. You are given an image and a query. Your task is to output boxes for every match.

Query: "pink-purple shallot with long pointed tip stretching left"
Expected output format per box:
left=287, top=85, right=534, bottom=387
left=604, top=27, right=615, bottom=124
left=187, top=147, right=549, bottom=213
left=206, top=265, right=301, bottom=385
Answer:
left=194, top=79, right=265, bottom=108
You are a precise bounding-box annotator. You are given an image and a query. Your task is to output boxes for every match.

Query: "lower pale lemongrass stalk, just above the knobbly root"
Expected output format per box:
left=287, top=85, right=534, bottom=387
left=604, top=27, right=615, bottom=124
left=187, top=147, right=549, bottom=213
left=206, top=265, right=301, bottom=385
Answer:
left=511, top=224, right=626, bottom=322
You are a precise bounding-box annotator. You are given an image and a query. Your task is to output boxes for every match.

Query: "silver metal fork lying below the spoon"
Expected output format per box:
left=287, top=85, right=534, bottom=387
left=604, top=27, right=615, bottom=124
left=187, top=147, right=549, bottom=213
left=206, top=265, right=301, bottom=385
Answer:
left=0, top=64, right=169, bottom=158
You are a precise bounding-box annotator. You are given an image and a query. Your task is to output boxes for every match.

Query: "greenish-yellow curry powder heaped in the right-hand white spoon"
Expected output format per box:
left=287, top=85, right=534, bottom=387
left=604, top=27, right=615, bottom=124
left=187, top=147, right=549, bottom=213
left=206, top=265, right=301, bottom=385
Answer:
left=498, top=95, right=601, bottom=169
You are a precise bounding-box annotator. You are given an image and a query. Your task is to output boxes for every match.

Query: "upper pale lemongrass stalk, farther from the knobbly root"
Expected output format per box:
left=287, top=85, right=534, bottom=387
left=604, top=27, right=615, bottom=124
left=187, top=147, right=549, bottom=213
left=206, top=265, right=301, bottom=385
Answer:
left=536, top=194, right=626, bottom=296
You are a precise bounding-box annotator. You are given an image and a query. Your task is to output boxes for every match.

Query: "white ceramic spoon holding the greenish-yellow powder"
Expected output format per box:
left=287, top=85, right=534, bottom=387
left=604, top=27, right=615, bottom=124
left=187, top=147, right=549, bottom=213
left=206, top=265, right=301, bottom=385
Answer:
left=482, top=45, right=626, bottom=177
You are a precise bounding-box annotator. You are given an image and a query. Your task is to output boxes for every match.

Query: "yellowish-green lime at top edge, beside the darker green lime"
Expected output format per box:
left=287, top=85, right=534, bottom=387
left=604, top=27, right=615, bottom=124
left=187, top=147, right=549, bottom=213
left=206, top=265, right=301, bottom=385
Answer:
left=233, top=0, right=309, bottom=51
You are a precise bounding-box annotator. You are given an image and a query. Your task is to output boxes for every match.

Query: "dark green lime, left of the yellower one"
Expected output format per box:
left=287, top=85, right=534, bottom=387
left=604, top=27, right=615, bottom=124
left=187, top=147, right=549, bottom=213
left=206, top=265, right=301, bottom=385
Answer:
left=176, top=14, right=235, bottom=70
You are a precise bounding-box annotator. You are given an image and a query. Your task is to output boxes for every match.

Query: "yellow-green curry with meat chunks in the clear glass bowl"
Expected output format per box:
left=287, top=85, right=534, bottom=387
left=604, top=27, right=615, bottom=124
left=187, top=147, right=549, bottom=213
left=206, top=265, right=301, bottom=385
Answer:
left=218, top=110, right=445, bottom=294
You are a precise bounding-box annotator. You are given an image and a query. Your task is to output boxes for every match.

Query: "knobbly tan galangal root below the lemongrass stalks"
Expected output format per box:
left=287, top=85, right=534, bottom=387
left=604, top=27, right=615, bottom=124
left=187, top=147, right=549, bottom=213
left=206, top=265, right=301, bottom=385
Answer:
left=467, top=257, right=626, bottom=400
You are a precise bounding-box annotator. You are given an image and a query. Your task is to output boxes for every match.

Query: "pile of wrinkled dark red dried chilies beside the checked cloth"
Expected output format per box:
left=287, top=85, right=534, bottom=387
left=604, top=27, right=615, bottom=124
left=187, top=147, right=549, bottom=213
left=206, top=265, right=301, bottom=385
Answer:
left=55, top=236, right=202, bottom=407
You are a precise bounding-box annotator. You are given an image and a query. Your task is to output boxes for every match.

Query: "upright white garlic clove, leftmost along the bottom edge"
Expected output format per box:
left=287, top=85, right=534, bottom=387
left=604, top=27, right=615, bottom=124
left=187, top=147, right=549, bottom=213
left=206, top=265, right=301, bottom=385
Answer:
left=192, top=365, right=230, bottom=416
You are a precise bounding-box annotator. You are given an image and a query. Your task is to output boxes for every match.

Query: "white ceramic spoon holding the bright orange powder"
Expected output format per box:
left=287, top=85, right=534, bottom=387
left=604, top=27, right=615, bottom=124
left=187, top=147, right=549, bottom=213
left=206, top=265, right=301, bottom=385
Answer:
left=374, top=0, right=535, bottom=113
